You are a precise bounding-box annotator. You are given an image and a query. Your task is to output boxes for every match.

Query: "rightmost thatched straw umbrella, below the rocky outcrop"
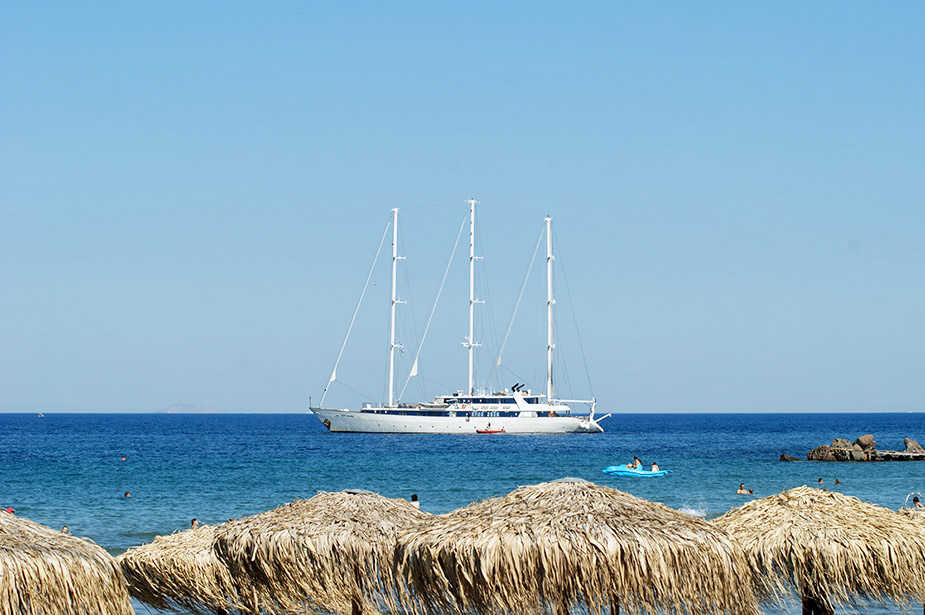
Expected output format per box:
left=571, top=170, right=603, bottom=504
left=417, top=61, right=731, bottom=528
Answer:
left=714, top=487, right=925, bottom=614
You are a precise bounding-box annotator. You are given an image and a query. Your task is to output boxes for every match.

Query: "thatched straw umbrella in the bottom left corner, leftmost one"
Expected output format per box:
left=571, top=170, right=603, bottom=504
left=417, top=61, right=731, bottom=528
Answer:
left=0, top=512, right=133, bottom=615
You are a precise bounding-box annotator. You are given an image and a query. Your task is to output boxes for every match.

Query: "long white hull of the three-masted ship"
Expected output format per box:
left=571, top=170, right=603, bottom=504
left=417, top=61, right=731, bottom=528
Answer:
left=312, top=408, right=604, bottom=435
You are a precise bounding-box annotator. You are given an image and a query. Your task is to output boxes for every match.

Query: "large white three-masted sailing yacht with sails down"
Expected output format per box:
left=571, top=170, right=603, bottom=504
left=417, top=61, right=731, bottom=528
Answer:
left=311, top=199, right=610, bottom=434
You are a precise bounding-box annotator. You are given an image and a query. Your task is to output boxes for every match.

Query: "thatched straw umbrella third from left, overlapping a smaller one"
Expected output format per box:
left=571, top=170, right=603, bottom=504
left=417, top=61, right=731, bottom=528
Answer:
left=215, top=491, right=433, bottom=614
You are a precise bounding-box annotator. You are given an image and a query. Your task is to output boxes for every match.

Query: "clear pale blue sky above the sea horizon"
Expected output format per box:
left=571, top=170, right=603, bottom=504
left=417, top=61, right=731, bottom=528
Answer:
left=0, top=1, right=925, bottom=413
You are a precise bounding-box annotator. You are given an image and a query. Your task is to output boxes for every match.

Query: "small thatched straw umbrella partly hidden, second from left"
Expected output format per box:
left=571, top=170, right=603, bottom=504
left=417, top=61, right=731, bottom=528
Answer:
left=116, top=525, right=253, bottom=613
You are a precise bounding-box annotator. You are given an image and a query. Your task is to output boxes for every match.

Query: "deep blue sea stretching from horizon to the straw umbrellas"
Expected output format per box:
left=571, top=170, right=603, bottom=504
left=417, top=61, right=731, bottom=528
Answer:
left=0, top=413, right=925, bottom=614
